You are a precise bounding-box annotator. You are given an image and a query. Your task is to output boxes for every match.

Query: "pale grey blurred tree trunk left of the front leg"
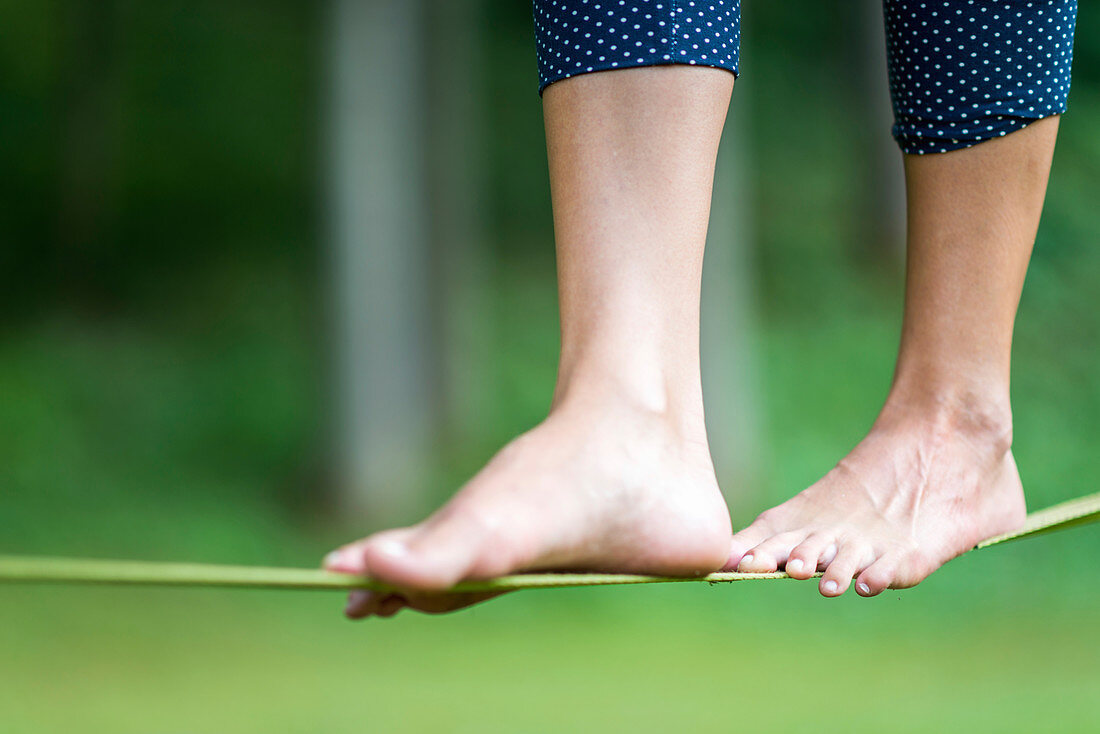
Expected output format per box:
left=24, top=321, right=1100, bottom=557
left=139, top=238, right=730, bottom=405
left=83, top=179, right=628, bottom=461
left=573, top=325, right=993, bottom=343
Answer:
left=328, top=0, right=437, bottom=526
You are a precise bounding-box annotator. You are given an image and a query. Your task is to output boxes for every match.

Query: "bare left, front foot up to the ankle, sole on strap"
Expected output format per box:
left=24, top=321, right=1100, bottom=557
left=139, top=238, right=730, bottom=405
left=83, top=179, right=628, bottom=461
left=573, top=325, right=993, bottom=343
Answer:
left=325, top=393, right=730, bottom=617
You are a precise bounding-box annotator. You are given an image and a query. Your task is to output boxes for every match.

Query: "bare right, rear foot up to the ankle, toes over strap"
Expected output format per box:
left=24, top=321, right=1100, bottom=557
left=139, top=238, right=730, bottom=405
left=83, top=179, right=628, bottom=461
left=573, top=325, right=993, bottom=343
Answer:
left=725, top=407, right=1026, bottom=596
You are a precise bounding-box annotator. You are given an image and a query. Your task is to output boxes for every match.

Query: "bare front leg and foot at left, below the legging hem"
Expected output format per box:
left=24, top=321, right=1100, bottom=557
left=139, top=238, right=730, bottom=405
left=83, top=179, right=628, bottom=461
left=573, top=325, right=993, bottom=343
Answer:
left=327, top=66, right=734, bottom=616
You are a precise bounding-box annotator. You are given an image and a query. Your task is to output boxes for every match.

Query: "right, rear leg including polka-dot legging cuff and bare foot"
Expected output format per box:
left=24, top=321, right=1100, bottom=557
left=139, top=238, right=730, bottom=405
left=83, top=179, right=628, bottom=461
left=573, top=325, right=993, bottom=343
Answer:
left=727, top=0, right=1077, bottom=596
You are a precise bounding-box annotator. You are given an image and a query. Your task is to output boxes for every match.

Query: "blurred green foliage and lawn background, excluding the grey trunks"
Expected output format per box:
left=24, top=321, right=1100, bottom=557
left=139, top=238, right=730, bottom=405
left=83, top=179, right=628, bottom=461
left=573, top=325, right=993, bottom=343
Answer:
left=0, top=0, right=1100, bottom=734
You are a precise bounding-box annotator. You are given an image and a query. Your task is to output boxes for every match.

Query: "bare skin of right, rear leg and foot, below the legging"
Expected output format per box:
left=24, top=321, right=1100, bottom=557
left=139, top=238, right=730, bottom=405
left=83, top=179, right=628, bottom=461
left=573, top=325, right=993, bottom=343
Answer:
left=730, top=117, right=1058, bottom=596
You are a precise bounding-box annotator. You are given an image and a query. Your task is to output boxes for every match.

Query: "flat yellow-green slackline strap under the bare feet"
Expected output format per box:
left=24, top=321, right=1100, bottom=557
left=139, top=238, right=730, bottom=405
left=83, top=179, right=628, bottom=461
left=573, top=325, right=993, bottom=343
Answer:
left=0, top=492, right=1100, bottom=593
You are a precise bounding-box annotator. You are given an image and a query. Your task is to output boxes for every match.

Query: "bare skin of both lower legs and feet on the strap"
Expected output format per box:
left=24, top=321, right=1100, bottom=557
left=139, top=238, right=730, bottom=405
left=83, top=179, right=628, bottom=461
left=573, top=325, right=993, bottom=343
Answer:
left=325, top=66, right=1058, bottom=618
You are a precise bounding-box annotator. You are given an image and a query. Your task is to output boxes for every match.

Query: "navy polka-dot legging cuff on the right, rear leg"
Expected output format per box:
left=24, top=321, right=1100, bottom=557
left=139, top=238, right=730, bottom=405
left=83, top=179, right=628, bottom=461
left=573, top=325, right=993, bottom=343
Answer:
left=883, top=0, right=1077, bottom=153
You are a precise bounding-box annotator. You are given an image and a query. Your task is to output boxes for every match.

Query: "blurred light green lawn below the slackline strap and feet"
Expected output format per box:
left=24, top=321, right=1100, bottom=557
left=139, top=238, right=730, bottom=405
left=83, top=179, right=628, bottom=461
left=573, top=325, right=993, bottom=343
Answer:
left=0, top=529, right=1100, bottom=734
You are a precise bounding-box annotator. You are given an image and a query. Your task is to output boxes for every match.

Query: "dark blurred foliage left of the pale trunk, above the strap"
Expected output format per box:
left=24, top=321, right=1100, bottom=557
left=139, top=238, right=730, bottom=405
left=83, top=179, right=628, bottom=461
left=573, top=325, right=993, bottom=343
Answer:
left=0, top=0, right=323, bottom=560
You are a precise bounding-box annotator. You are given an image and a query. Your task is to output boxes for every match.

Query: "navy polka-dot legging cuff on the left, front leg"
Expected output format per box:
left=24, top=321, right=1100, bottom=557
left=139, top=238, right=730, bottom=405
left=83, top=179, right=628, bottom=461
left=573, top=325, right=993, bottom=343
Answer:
left=534, top=0, right=741, bottom=94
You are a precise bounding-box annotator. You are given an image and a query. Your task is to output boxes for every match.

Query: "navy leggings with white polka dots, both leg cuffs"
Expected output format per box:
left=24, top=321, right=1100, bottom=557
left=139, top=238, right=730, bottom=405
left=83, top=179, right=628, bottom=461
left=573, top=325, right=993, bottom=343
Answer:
left=534, top=0, right=1077, bottom=153
